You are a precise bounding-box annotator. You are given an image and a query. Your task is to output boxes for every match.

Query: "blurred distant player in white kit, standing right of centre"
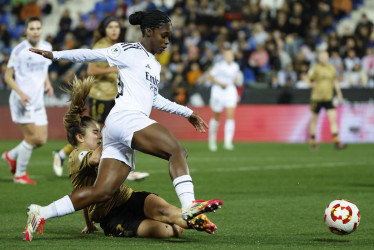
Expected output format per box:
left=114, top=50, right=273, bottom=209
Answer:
left=209, top=49, right=242, bottom=151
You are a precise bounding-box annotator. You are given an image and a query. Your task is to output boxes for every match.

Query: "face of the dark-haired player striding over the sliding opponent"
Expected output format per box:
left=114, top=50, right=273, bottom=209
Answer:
left=151, top=23, right=173, bottom=54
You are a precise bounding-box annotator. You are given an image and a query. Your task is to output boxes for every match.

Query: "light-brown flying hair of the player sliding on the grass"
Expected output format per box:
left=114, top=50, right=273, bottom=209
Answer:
left=61, top=76, right=95, bottom=146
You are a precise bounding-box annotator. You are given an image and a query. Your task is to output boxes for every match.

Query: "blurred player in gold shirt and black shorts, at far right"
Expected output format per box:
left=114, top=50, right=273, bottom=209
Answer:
left=306, top=51, right=346, bottom=150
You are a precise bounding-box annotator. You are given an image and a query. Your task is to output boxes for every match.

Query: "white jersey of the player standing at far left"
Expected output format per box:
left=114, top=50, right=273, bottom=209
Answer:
left=7, top=40, right=52, bottom=109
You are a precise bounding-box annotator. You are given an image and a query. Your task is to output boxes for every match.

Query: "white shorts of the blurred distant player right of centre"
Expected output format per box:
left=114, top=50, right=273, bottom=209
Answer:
left=209, top=86, right=238, bottom=113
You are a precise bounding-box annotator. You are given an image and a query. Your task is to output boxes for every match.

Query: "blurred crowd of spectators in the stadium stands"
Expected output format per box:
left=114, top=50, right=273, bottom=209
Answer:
left=0, top=0, right=374, bottom=104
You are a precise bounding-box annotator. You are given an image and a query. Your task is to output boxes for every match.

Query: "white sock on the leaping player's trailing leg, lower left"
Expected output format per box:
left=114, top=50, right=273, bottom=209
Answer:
left=40, top=195, right=75, bottom=220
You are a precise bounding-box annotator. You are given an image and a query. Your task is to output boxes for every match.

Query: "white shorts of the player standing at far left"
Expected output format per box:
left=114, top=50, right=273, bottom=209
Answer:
left=9, top=91, right=48, bottom=126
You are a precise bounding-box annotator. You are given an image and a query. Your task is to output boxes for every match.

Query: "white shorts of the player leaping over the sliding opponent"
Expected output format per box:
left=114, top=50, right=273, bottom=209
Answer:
left=101, top=110, right=156, bottom=171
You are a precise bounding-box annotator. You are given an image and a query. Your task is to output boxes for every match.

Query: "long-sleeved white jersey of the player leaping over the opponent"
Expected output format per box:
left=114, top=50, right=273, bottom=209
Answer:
left=53, top=43, right=193, bottom=118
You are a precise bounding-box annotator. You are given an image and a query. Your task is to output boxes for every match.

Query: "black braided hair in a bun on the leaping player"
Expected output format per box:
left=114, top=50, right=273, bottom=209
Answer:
left=129, top=10, right=171, bottom=37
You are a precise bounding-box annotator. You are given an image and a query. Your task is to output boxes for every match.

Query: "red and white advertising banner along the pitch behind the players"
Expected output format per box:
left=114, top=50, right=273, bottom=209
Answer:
left=0, top=104, right=374, bottom=143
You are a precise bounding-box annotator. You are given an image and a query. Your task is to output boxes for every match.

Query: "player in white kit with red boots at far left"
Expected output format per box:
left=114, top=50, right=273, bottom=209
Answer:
left=2, top=17, right=53, bottom=184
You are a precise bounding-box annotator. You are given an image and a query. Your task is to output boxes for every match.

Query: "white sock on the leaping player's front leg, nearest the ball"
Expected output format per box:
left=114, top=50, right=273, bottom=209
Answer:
left=173, top=175, right=195, bottom=209
